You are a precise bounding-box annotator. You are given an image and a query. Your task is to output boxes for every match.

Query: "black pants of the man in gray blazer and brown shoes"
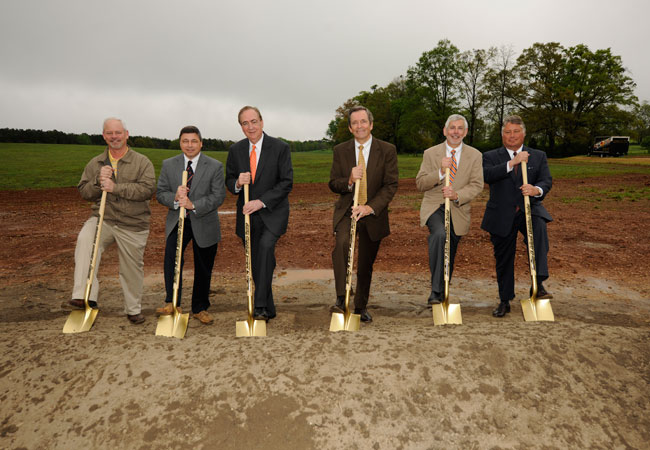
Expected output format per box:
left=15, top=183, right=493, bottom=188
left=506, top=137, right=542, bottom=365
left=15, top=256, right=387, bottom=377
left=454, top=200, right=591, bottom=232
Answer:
left=164, top=213, right=218, bottom=314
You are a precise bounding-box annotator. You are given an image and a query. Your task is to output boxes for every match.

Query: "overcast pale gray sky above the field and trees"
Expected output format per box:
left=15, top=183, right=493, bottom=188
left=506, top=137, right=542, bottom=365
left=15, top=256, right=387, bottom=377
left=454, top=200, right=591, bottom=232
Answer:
left=0, top=0, right=650, bottom=140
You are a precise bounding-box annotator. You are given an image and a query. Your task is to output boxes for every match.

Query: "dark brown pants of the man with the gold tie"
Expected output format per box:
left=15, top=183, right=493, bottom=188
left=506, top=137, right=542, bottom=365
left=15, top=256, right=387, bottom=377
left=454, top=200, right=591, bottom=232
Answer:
left=332, top=216, right=381, bottom=309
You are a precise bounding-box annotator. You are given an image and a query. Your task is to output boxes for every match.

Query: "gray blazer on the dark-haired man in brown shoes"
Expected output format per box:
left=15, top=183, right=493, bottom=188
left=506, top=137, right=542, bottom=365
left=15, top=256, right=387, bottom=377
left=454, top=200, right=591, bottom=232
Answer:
left=156, top=152, right=226, bottom=248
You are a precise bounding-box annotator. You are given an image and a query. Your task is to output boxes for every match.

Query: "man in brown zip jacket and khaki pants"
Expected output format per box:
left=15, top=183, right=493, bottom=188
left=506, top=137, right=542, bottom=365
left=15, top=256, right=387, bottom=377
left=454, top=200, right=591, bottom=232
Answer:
left=70, top=118, right=156, bottom=324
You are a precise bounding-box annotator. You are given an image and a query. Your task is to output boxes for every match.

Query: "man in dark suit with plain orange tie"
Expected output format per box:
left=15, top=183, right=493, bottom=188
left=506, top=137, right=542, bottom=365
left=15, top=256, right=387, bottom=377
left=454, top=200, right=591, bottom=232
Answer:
left=226, top=106, right=293, bottom=321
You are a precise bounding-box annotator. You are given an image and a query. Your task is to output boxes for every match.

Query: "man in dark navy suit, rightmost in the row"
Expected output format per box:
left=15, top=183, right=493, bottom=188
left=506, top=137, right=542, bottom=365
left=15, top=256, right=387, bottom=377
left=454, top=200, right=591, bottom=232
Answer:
left=481, top=116, right=553, bottom=317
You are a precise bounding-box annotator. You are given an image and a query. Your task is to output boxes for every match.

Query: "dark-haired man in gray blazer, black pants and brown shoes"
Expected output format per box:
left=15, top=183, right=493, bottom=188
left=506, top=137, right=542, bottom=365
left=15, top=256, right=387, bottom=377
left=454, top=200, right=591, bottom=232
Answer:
left=156, top=126, right=226, bottom=324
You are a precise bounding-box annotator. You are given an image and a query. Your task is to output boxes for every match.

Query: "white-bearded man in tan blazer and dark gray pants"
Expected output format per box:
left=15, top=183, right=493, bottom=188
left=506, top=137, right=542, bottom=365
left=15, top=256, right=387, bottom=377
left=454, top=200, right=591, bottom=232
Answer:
left=415, top=114, right=483, bottom=306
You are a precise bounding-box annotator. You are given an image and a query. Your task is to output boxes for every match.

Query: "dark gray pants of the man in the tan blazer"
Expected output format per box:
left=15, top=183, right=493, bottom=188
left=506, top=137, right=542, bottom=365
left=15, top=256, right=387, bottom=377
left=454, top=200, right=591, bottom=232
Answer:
left=427, top=205, right=460, bottom=299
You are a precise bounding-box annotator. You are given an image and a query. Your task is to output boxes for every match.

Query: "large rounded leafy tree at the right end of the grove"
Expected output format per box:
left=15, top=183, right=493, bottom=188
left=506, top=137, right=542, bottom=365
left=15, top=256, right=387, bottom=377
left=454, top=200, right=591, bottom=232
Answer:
left=510, top=42, right=636, bottom=155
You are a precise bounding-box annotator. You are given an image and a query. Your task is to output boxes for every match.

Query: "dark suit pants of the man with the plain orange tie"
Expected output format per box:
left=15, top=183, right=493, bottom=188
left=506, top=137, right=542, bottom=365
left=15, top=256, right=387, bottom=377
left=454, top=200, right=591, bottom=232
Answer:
left=242, top=213, right=279, bottom=317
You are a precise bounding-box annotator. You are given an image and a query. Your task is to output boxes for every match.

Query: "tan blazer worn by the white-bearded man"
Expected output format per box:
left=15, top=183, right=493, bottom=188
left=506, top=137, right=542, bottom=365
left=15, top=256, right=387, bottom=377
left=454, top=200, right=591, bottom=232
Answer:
left=415, top=142, right=483, bottom=236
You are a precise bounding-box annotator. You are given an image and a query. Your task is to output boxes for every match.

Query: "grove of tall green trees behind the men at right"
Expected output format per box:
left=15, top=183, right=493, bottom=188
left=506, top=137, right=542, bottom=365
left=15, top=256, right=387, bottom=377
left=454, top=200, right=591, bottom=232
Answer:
left=326, top=39, right=650, bottom=157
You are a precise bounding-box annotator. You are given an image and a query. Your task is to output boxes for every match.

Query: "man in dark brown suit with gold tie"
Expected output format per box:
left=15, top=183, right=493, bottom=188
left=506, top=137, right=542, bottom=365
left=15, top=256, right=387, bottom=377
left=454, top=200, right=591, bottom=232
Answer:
left=329, top=106, right=399, bottom=322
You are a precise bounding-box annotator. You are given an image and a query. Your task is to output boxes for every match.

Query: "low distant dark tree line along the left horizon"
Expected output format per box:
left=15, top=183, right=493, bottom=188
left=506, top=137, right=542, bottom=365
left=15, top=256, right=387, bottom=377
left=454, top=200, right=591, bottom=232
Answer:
left=0, top=128, right=330, bottom=152
